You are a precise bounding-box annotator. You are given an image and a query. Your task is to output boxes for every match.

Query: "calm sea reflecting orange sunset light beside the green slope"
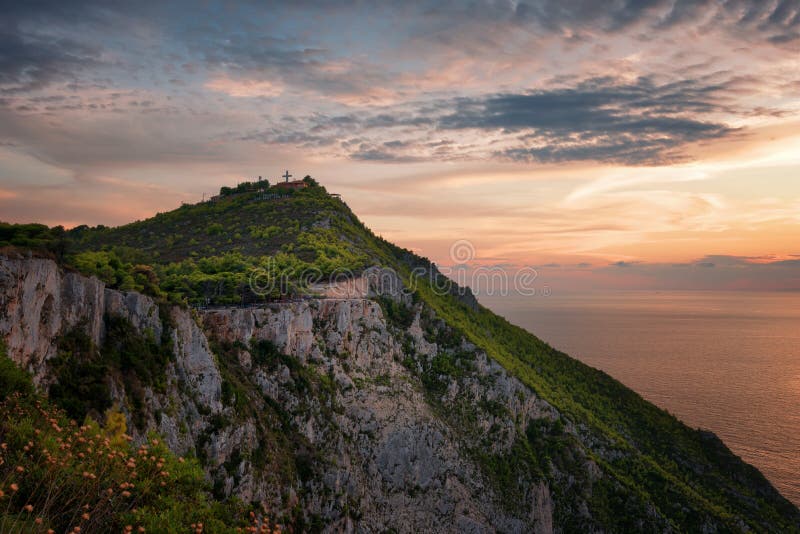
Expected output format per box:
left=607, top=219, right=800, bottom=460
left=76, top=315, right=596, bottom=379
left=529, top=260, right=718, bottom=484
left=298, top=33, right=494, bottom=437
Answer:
left=479, top=291, right=800, bottom=505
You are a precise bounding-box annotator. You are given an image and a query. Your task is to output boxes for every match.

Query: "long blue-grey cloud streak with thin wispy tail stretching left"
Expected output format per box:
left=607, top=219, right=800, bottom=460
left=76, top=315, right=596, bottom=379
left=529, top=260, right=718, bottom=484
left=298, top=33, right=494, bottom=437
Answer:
left=247, top=77, right=741, bottom=165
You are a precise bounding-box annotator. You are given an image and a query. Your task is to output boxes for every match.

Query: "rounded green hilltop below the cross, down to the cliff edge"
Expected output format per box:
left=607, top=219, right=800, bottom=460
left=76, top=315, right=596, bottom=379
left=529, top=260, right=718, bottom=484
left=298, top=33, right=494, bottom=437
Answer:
left=68, top=177, right=418, bottom=304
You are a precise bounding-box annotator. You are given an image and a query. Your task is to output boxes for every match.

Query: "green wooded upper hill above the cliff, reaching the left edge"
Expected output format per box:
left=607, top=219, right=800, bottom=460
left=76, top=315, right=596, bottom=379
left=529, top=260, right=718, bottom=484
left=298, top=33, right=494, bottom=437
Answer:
left=0, top=179, right=376, bottom=304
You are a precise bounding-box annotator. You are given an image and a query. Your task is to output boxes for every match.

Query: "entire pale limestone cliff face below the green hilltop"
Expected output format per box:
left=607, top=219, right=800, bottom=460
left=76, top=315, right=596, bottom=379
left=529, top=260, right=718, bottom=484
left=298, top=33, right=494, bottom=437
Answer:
left=0, top=255, right=796, bottom=533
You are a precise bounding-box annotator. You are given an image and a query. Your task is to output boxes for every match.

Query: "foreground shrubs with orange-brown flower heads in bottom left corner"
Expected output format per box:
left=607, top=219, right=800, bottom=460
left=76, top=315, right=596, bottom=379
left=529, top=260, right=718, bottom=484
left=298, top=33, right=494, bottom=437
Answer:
left=0, top=351, right=272, bottom=534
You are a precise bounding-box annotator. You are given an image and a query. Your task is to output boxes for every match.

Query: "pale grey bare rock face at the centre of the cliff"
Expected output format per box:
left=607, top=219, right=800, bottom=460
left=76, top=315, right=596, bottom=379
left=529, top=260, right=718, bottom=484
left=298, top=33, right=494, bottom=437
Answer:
left=204, top=300, right=552, bottom=532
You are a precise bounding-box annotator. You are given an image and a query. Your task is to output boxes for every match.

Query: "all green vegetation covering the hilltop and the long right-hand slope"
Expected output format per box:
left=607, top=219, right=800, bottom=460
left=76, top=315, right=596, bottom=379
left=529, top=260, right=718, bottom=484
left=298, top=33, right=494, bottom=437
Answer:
left=0, top=180, right=800, bottom=532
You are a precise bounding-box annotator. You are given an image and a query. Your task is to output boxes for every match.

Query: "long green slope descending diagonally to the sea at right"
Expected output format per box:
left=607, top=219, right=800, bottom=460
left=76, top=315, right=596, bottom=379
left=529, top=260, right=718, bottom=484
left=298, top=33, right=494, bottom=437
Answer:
left=406, top=283, right=800, bottom=532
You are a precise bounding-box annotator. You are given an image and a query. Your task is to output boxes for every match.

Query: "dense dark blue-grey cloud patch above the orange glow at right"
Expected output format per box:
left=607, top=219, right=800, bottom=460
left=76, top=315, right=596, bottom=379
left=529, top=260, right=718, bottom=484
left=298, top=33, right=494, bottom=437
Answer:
left=439, top=77, right=733, bottom=164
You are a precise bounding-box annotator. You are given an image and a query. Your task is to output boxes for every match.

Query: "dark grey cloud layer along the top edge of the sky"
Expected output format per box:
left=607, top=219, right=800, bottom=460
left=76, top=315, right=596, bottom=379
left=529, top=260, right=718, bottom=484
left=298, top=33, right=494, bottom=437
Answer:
left=0, top=0, right=800, bottom=100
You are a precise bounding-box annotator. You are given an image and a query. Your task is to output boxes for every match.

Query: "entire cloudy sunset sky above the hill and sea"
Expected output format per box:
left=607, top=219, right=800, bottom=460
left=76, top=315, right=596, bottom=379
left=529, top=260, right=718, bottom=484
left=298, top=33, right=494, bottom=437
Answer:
left=0, top=0, right=800, bottom=289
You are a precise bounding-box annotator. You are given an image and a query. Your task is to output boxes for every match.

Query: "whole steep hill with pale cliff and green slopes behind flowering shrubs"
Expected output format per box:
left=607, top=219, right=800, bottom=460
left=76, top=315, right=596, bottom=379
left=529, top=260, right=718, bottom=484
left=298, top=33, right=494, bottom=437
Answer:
left=0, top=182, right=800, bottom=532
